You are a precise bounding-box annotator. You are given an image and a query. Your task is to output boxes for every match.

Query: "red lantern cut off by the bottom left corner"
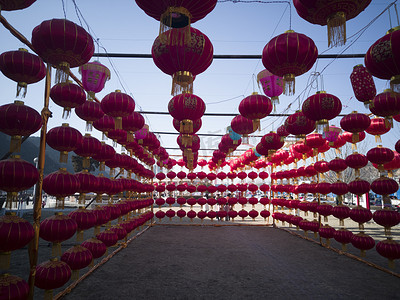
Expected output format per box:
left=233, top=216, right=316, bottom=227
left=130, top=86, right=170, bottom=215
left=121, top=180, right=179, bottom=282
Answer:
left=0, top=273, right=29, bottom=300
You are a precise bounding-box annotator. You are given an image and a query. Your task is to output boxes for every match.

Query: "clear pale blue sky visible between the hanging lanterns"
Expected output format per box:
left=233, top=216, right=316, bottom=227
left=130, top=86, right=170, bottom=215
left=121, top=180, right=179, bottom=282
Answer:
left=0, top=0, right=400, bottom=169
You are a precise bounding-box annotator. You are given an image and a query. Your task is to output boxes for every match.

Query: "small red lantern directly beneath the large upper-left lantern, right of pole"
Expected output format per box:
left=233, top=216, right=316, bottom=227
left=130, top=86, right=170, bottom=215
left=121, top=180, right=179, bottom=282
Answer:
left=50, top=81, right=86, bottom=119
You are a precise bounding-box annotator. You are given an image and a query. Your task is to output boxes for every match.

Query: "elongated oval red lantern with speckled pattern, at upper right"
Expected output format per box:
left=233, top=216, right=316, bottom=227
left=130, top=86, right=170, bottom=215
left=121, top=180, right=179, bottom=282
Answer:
left=352, top=65, right=376, bottom=106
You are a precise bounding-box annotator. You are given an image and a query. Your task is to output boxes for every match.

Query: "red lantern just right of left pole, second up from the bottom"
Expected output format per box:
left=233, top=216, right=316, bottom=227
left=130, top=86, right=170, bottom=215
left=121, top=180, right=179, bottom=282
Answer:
left=39, top=212, right=78, bottom=256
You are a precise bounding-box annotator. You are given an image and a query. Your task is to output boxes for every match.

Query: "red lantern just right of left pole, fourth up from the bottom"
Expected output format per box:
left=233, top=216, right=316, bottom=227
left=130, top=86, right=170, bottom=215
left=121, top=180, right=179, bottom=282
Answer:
left=46, top=123, right=82, bottom=163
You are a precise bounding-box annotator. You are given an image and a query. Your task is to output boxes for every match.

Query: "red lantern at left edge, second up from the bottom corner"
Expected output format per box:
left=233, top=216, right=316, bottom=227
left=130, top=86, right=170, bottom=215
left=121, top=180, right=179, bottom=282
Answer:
left=0, top=212, right=34, bottom=269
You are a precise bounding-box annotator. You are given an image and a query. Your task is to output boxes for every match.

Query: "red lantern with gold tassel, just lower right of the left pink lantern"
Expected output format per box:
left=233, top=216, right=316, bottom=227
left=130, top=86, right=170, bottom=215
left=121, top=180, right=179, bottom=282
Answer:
left=101, top=90, right=135, bottom=129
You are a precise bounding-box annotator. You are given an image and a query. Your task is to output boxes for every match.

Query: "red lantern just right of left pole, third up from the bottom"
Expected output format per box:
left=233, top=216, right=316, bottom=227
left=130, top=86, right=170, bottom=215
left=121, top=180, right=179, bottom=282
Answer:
left=43, top=168, right=80, bottom=209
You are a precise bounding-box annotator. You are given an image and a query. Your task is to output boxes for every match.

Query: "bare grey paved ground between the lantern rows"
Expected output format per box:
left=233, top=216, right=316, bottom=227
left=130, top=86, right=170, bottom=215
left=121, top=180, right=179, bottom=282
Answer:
left=65, top=225, right=400, bottom=300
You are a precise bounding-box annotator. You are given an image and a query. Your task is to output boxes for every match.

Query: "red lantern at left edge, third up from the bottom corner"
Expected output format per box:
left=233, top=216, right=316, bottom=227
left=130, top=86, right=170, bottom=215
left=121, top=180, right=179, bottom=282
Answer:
left=0, top=155, right=39, bottom=209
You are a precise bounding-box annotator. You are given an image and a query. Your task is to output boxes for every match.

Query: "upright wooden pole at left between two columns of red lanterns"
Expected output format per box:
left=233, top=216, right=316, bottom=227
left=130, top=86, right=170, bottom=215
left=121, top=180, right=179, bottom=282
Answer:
left=28, top=64, right=51, bottom=299
